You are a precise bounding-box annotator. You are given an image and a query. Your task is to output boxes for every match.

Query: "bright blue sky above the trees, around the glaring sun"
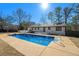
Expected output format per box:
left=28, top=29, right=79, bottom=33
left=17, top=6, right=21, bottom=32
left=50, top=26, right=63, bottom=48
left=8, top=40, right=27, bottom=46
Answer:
left=0, top=3, right=72, bottom=23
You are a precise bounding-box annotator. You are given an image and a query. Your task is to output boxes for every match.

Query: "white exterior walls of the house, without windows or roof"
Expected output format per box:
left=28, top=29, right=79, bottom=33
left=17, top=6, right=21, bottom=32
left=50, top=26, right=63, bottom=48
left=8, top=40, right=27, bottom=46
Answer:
left=30, top=27, right=65, bottom=35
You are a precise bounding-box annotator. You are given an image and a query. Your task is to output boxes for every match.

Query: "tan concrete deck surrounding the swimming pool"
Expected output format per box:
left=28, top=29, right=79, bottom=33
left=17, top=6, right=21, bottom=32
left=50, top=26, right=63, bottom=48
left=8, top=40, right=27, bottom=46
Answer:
left=0, top=33, right=79, bottom=56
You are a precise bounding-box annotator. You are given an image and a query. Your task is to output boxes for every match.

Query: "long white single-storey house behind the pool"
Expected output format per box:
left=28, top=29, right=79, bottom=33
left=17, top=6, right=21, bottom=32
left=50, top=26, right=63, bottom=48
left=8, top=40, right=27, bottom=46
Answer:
left=28, top=25, right=66, bottom=35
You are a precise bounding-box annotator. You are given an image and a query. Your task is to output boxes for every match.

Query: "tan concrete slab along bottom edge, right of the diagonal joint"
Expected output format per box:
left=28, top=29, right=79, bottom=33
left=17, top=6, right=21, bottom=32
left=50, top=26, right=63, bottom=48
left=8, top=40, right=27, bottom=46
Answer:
left=41, top=48, right=75, bottom=56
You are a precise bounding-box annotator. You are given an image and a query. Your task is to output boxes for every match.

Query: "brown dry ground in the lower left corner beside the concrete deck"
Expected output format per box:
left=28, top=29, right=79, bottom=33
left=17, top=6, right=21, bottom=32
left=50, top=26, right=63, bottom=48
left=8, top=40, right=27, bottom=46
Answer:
left=0, top=40, right=23, bottom=56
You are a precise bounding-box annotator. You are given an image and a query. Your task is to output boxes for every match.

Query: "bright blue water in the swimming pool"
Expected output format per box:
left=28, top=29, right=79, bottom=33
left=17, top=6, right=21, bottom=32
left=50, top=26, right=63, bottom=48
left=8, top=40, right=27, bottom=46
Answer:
left=11, top=34, right=54, bottom=46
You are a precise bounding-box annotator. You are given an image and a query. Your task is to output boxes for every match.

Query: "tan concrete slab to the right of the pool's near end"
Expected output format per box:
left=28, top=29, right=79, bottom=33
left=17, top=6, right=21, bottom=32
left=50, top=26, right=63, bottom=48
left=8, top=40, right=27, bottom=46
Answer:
left=49, top=36, right=79, bottom=55
